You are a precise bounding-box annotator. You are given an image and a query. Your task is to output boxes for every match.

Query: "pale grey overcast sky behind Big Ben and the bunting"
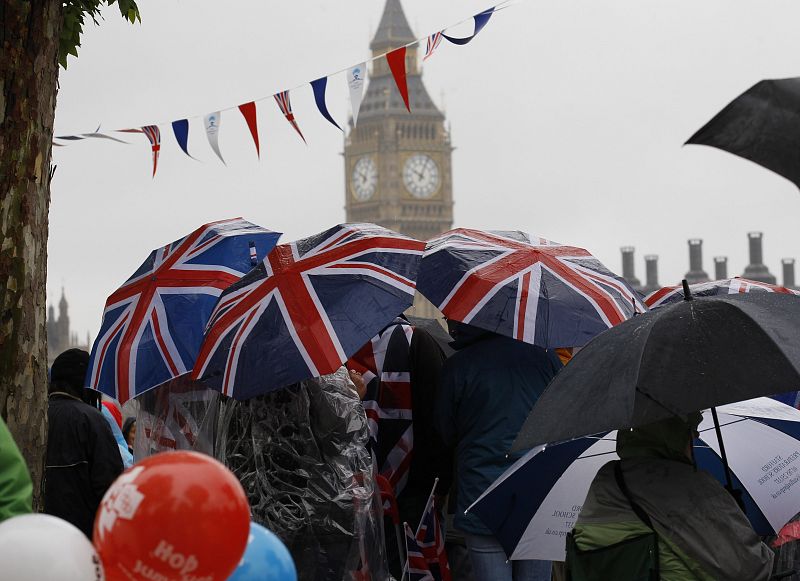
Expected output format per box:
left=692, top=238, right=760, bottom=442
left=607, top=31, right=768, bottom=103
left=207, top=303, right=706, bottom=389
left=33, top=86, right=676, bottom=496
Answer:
left=48, top=0, right=800, bottom=338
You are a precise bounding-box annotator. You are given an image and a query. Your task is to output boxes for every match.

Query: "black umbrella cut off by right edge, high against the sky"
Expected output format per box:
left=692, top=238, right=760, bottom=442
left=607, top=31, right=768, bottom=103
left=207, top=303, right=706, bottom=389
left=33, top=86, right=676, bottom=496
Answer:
left=686, top=77, right=800, bottom=188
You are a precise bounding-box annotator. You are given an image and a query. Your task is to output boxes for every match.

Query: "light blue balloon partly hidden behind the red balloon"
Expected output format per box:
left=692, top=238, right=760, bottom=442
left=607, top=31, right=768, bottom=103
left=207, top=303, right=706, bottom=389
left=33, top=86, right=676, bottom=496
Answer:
left=228, top=522, right=297, bottom=581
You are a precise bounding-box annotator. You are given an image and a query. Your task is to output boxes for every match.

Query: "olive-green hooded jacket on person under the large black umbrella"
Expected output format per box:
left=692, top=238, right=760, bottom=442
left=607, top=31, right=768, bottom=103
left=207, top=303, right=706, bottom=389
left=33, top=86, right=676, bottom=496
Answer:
left=574, top=413, right=773, bottom=581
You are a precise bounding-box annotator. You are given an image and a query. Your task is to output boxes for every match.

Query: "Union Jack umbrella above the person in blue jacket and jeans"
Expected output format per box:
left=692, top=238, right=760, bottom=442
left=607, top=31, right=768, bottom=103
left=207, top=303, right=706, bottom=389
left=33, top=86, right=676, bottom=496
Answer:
left=417, top=228, right=647, bottom=349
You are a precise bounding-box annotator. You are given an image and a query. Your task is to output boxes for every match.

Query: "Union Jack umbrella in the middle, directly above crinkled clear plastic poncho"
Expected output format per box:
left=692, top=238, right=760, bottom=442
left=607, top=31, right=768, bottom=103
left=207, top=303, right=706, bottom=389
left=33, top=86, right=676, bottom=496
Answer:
left=193, top=224, right=425, bottom=399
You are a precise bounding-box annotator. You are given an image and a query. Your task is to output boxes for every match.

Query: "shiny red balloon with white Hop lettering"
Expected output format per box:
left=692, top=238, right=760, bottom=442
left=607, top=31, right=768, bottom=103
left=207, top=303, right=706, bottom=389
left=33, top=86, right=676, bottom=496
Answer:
left=94, top=452, right=250, bottom=581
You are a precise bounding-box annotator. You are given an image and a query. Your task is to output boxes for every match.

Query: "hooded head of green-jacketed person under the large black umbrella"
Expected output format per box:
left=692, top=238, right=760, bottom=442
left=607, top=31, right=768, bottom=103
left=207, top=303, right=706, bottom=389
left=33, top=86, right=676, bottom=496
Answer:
left=617, top=412, right=703, bottom=464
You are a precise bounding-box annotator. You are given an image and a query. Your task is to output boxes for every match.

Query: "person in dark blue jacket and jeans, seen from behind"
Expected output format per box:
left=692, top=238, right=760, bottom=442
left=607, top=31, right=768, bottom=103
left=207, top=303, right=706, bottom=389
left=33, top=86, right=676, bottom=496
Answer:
left=434, top=321, right=562, bottom=581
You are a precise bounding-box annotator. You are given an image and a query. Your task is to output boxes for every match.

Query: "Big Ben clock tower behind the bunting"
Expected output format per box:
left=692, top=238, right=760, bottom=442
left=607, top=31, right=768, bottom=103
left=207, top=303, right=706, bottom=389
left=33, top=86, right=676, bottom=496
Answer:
left=344, top=0, right=453, bottom=240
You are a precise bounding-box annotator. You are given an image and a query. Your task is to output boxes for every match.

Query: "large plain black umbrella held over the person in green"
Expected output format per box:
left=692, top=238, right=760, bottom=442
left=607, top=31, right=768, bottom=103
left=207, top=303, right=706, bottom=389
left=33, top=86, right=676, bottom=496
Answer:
left=513, top=293, right=800, bottom=450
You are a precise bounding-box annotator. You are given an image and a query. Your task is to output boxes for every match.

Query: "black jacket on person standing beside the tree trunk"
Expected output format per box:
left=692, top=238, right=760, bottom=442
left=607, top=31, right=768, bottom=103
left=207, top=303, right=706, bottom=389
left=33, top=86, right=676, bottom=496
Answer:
left=44, top=394, right=123, bottom=539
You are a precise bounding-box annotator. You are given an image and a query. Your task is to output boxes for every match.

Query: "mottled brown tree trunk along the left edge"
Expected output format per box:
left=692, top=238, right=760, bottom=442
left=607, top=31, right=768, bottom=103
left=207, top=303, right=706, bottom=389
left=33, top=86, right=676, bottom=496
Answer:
left=0, top=0, right=62, bottom=510
